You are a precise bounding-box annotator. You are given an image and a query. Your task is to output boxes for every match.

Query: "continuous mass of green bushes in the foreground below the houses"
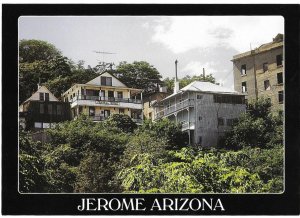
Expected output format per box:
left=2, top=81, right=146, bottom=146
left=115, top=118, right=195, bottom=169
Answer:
left=20, top=100, right=284, bottom=193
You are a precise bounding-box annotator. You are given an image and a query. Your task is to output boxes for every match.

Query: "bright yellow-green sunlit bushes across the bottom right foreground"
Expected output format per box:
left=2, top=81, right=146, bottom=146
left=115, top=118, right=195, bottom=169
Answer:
left=118, top=148, right=283, bottom=193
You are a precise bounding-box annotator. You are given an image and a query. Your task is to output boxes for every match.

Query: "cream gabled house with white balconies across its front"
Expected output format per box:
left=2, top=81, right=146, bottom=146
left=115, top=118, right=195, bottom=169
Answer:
left=62, top=72, right=143, bottom=124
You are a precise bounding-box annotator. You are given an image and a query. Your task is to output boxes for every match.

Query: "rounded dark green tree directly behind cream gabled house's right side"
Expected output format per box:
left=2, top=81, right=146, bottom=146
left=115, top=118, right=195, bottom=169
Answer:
left=112, top=61, right=162, bottom=92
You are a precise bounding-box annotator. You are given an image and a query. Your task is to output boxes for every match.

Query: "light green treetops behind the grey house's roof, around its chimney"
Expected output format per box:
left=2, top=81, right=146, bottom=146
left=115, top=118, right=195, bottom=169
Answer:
left=163, top=74, right=216, bottom=93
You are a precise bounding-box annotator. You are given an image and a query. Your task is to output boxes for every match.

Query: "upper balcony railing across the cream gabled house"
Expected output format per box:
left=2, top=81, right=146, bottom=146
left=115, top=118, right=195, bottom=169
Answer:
left=71, top=95, right=142, bottom=104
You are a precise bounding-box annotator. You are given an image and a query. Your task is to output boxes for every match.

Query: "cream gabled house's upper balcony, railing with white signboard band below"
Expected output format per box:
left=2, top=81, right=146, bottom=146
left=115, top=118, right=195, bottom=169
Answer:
left=70, top=95, right=142, bottom=109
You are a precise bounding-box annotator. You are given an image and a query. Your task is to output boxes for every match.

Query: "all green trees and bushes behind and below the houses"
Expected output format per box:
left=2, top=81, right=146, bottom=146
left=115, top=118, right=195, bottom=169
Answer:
left=19, top=40, right=284, bottom=193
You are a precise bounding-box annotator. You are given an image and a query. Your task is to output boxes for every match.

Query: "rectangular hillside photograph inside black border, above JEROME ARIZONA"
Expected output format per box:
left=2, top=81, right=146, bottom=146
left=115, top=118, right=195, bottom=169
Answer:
left=18, top=16, right=284, bottom=193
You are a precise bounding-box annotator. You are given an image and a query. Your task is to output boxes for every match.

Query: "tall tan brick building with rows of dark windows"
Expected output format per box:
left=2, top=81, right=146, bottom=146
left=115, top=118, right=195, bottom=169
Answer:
left=232, top=34, right=284, bottom=111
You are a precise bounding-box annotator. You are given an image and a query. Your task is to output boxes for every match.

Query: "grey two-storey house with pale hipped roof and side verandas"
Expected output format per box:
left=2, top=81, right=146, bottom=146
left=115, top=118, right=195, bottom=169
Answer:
left=155, top=81, right=246, bottom=147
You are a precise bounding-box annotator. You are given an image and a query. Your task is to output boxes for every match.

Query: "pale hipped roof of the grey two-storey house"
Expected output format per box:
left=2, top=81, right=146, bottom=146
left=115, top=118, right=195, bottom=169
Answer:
left=163, top=81, right=242, bottom=100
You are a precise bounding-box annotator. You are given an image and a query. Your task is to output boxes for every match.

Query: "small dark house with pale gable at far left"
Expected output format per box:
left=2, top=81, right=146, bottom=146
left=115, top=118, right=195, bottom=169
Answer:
left=19, top=86, right=71, bottom=130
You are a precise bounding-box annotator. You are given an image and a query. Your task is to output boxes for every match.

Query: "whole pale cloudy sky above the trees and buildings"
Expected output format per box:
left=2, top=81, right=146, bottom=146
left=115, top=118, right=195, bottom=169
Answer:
left=19, top=16, right=284, bottom=89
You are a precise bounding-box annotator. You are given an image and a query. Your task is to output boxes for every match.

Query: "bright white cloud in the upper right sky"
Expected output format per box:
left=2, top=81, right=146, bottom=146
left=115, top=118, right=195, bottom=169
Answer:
left=152, top=16, right=284, bottom=53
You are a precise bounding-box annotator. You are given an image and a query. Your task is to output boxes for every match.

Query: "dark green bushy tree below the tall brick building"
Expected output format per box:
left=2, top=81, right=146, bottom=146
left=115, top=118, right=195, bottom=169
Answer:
left=223, top=98, right=283, bottom=149
